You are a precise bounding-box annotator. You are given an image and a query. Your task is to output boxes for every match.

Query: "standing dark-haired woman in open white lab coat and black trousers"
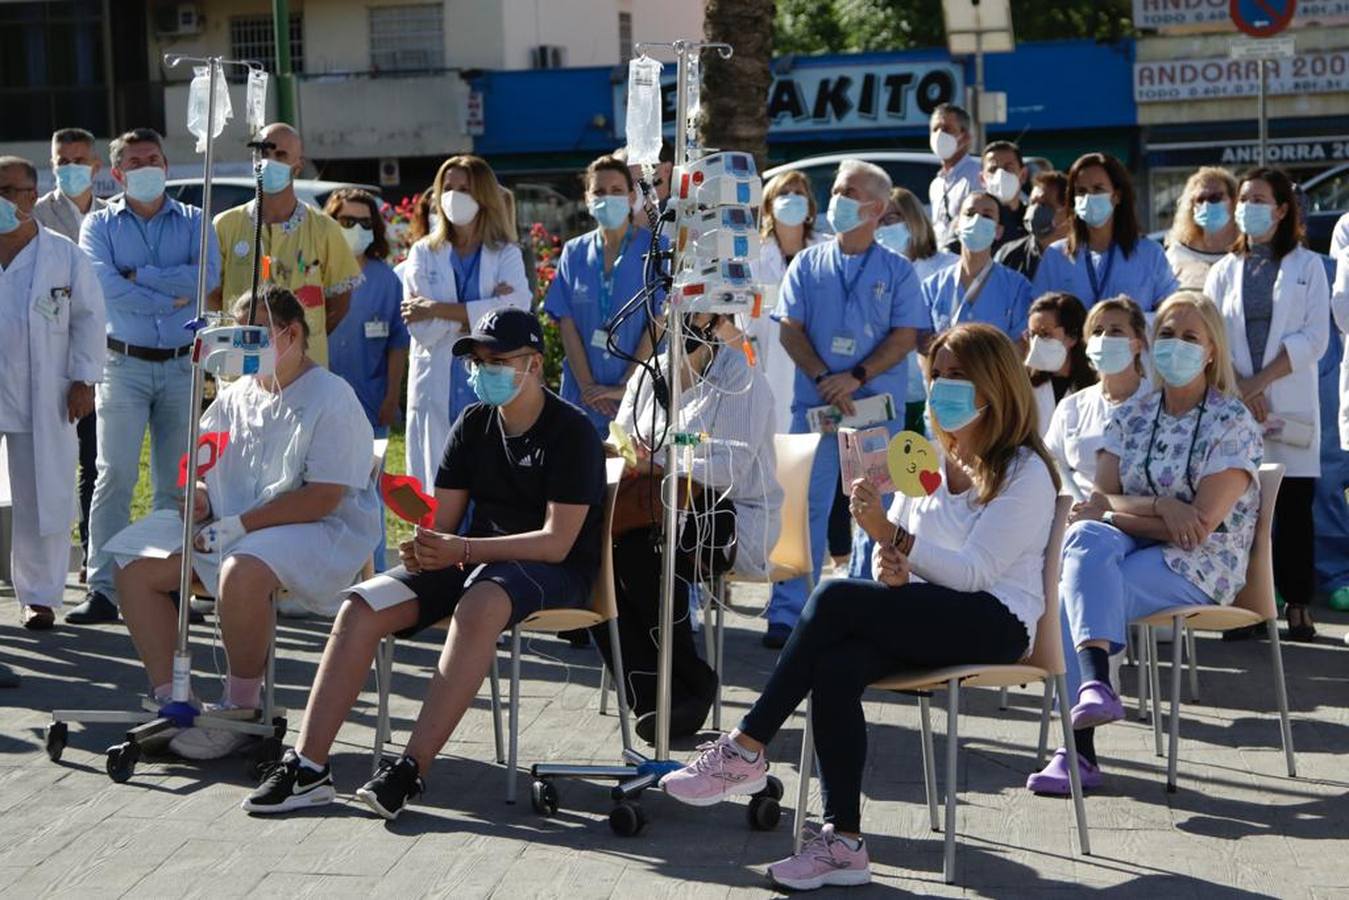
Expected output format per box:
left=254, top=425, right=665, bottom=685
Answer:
left=1203, top=169, right=1330, bottom=641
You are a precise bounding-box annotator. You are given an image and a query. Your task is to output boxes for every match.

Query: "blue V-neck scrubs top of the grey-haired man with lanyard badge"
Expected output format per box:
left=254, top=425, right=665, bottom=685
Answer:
left=773, top=240, right=931, bottom=417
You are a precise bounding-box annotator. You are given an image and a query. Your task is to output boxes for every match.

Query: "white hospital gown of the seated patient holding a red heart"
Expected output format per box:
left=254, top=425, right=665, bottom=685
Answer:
left=115, top=366, right=383, bottom=617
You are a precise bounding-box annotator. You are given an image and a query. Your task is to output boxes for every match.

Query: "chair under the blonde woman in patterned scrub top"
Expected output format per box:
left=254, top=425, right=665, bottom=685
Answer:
left=1130, top=463, right=1298, bottom=793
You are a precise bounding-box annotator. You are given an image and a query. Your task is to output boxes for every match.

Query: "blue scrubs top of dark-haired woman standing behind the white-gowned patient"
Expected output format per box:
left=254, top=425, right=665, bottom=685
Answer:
left=328, top=259, right=411, bottom=437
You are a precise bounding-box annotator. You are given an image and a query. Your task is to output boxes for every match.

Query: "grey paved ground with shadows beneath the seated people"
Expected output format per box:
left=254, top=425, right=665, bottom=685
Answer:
left=0, top=588, right=1349, bottom=900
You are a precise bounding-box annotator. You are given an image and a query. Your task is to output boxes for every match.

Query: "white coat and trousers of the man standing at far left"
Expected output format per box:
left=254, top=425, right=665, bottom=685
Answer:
left=0, top=228, right=107, bottom=606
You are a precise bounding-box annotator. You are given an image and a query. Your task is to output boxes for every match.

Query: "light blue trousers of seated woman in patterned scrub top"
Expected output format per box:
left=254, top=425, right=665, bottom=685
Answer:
left=1059, top=521, right=1213, bottom=704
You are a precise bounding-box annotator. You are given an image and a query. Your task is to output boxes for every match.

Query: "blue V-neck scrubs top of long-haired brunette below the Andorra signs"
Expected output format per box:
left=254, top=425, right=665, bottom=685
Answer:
left=1031, top=237, right=1180, bottom=313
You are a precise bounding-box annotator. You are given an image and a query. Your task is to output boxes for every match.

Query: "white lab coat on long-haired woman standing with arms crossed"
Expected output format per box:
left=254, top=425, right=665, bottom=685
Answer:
left=402, top=237, right=530, bottom=490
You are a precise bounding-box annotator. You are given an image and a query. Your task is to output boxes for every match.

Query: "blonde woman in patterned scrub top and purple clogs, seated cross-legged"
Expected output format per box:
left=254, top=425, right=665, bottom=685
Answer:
left=1027, top=290, right=1261, bottom=795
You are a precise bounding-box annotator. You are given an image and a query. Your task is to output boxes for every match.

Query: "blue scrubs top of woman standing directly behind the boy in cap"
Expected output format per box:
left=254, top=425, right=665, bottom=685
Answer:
left=544, top=228, right=665, bottom=437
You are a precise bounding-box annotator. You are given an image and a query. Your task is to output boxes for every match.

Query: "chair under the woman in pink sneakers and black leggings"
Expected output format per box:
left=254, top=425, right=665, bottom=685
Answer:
left=793, top=497, right=1091, bottom=884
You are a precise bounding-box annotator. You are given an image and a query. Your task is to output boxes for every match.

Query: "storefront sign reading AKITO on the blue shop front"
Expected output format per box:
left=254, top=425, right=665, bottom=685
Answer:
left=614, top=62, right=965, bottom=135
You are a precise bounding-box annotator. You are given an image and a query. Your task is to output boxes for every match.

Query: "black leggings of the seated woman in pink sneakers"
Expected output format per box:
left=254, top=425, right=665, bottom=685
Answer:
left=741, top=579, right=1028, bottom=831
